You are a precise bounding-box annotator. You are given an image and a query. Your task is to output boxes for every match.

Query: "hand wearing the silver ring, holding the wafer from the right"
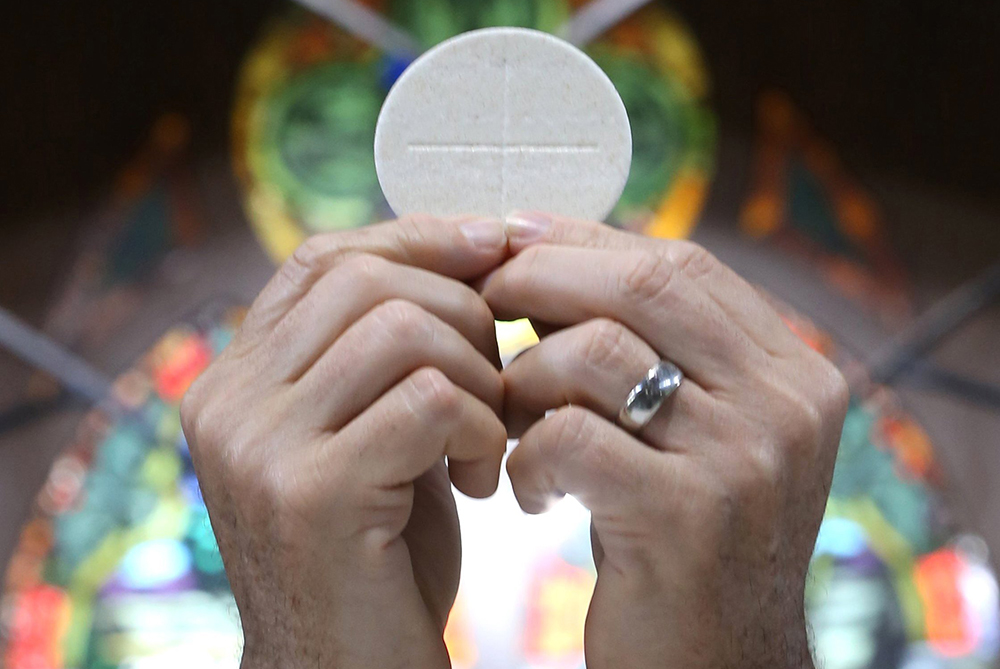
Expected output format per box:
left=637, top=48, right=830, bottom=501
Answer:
left=482, top=214, right=848, bottom=669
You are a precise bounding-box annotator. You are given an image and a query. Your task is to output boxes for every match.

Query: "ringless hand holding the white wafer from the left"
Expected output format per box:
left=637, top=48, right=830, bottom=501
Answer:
left=181, top=219, right=507, bottom=669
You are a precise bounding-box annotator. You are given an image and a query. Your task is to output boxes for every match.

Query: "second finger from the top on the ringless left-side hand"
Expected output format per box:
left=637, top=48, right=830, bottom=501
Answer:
left=266, top=253, right=500, bottom=381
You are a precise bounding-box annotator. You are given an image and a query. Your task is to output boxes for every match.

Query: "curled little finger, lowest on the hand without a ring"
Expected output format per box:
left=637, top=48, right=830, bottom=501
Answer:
left=328, top=368, right=507, bottom=497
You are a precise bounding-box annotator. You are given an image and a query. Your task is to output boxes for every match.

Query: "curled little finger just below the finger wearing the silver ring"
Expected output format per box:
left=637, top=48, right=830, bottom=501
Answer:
left=507, top=407, right=677, bottom=523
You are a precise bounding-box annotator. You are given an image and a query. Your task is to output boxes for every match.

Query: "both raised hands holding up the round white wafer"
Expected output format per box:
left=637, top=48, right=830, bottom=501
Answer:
left=181, top=214, right=848, bottom=669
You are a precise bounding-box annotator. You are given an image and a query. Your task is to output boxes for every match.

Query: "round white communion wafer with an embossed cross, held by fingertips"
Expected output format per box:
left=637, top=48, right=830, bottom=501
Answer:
left=375, top=28, right=632, bottom=220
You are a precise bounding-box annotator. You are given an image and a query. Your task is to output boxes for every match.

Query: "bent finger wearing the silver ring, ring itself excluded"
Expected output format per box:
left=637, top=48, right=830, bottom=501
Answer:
left=501, top=318, right=714, bottom=451
